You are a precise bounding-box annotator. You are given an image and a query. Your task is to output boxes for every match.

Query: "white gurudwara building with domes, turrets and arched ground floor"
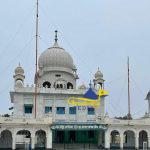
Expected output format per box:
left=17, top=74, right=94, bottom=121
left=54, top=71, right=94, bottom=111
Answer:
left=0, top=32, right=150, bottom=150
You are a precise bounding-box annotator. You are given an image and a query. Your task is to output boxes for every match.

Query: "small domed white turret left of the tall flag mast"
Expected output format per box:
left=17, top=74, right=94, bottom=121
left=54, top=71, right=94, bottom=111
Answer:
left=13, top=63, right=25, bottom=87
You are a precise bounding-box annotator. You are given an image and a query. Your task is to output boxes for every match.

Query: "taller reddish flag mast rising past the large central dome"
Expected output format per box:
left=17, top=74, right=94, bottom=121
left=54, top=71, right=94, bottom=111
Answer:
left=34, top=0, right=39, bottom=118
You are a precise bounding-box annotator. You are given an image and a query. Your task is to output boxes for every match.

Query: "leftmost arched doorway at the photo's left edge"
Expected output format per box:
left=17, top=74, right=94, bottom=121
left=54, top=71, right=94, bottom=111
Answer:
left=0, top=130, right=12, bottom=149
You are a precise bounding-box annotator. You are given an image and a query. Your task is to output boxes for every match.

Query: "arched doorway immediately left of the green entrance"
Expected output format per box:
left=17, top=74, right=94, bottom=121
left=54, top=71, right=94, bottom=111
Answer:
left=35, top=130, right=46, bottom=148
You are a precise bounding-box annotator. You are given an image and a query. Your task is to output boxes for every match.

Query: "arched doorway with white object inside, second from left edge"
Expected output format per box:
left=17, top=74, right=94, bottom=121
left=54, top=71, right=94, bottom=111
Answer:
left=16, top=130, right=31, bottom=149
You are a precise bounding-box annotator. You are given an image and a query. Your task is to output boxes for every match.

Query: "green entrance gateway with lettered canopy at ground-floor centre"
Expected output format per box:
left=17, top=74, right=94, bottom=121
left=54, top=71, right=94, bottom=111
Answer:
left=51, top=123, right=107, bottom=149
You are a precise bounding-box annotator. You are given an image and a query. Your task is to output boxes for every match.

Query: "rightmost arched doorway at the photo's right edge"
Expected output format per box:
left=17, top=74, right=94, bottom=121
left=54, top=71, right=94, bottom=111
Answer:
left=139, top=130, right=148, bottom=149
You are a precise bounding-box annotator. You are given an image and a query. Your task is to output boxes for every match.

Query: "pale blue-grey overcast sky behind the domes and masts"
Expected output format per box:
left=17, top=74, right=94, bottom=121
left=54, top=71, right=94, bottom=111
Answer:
left=0, top=0, right=150, bottom=117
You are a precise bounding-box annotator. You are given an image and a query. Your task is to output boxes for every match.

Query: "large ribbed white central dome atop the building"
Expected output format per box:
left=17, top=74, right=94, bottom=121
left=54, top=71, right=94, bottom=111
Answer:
left=38, top=41, right=74, bottom=69
